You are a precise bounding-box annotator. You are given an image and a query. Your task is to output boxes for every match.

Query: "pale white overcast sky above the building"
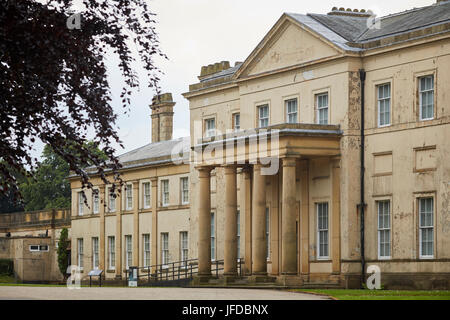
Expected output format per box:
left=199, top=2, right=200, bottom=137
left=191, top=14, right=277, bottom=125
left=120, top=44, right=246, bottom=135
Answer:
left=29, top=0, right=436, bottom=160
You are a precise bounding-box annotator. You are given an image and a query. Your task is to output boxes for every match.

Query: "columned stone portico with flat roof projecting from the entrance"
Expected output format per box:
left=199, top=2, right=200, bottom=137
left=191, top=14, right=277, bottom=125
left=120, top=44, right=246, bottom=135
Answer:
left=193, top=124, right=341, bottom=277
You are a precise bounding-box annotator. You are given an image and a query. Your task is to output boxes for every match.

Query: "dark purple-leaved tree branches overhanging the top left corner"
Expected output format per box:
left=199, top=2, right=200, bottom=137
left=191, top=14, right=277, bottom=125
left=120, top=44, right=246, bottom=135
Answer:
left=0, top=0, right=165, bottom=200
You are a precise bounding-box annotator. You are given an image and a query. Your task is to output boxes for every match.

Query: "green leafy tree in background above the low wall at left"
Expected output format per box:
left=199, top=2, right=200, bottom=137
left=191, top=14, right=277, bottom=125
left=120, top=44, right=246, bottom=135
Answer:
left=19, top=141, right=106, bottom=211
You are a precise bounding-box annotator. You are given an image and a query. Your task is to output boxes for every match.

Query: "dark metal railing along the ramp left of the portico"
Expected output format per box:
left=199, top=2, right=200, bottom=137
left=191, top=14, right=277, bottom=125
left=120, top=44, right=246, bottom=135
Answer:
left=125, top=259, right=244, bottom=285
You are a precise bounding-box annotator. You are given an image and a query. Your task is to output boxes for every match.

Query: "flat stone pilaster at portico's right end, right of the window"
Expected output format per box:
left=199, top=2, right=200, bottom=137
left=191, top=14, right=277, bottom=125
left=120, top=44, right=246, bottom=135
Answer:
left=331, top=158, right=341, bottom=274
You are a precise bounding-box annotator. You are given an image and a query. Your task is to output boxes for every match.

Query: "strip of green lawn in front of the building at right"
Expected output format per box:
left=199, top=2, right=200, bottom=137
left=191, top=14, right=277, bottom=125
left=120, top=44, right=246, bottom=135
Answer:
left=295, top=289, right=450, bottom=300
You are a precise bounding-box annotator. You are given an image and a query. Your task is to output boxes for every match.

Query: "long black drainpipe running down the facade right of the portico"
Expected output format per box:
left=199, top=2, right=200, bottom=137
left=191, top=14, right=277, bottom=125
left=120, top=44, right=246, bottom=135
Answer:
left=359, top=69, right=366, bottom=284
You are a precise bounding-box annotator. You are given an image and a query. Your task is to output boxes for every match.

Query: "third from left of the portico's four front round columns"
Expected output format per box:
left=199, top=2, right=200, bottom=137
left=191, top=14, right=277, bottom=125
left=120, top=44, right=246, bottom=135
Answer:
left=252, top=164, right=267, bottom=275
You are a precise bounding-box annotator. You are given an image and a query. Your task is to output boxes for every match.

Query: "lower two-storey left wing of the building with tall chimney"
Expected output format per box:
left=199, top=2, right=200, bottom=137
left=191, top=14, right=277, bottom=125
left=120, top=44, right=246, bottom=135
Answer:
left=69, top=94, right=191, bottom=280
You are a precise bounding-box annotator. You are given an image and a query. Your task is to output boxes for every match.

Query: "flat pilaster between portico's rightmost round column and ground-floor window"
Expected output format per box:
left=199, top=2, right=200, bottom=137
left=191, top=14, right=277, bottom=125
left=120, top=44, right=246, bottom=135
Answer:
left=300, top=160, right=309, bottom=274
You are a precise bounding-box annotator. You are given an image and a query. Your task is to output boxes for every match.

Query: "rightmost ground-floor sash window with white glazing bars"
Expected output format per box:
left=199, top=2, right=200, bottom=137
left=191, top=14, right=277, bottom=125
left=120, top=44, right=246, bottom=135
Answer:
left=419, top=198, right=434, bottom=258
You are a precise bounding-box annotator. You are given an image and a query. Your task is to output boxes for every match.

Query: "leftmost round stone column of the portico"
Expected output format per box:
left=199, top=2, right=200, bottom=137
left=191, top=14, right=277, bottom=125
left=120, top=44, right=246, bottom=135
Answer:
left=197, top=167, right=211, bottom=276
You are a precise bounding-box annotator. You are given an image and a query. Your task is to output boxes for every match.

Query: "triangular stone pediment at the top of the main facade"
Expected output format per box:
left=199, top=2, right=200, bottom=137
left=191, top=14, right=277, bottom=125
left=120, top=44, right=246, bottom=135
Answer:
left=236, top=16, right=341, bottom=78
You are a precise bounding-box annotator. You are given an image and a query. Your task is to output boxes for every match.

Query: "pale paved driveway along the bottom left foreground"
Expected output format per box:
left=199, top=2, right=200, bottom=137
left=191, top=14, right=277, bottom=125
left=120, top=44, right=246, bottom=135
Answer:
left=0, top=286, right=327, bottom=300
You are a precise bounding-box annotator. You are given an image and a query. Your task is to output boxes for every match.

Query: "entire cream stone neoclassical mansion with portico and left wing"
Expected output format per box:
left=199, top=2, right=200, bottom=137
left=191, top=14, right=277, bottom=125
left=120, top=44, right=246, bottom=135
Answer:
left=71, top=1, right=450, bottom=289
